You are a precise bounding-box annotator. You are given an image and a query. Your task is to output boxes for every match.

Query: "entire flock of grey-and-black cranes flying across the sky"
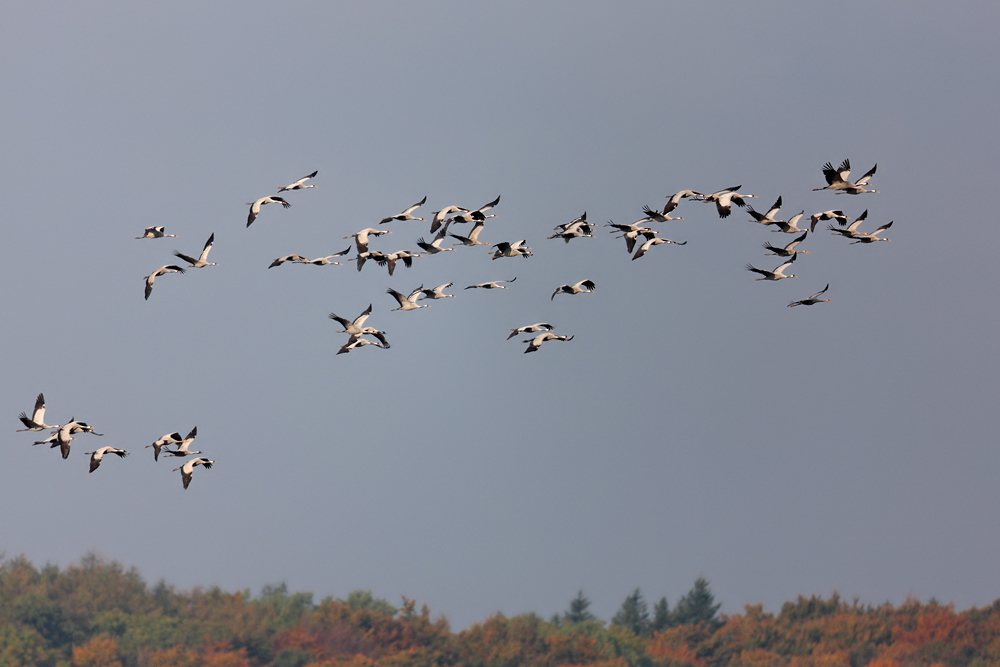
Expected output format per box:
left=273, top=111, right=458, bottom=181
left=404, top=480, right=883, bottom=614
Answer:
left=18, top=160, right=892, bottom=489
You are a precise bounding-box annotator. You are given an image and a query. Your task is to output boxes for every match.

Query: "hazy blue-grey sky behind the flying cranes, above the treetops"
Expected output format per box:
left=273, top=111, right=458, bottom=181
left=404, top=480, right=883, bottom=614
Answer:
left=0, top=1, right=1000, bottom=627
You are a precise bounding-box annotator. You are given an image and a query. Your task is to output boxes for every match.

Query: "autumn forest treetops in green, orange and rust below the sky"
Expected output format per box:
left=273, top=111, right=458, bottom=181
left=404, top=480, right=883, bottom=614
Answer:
left=0, top=555, right=1000, bottom=667
